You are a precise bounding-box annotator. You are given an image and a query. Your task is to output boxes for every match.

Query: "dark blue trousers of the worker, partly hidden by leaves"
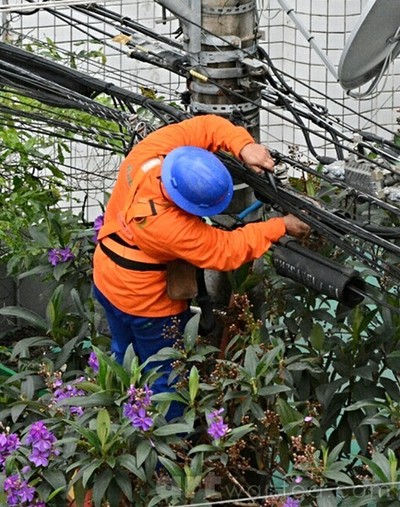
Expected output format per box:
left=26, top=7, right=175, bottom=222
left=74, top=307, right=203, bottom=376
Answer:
left=93, top=286, right=191, bottom=420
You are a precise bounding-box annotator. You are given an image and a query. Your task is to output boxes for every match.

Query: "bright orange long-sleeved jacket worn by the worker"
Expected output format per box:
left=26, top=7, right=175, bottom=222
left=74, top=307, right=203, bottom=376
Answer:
left=94, top=115, right=286, bottom=317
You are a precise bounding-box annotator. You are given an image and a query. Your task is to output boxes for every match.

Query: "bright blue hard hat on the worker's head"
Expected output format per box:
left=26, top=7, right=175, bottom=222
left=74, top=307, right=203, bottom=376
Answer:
left=161, top=146, right=233, bottom=216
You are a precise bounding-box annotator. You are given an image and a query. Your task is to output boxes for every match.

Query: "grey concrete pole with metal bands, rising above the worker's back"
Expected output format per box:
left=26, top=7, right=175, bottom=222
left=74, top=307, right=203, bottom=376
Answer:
left=189, top=0, right=261, bottom=139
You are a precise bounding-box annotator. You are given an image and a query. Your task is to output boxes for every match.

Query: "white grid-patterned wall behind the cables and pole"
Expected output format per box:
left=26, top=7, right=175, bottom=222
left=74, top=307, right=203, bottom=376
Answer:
left=2, top=0, right=400, bottom=218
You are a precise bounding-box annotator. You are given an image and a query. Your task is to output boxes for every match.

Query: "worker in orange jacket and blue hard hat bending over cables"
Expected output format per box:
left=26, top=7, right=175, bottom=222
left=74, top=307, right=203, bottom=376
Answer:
left=94, top=115, right=309, bottom=420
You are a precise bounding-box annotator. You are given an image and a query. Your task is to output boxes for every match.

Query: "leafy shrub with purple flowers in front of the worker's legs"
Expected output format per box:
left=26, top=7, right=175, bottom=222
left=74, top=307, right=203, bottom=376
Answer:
left=0, top=290, right=398, bottom=507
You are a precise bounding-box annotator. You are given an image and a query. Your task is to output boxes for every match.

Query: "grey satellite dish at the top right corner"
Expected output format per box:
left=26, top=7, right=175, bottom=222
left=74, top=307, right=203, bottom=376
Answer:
left=338, top=0, right=400, bottom=90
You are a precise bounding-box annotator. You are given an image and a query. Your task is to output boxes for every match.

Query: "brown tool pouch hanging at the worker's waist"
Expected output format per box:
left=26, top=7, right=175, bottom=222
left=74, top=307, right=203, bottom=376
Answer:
left=167, top=259, right=197, bottom=299
